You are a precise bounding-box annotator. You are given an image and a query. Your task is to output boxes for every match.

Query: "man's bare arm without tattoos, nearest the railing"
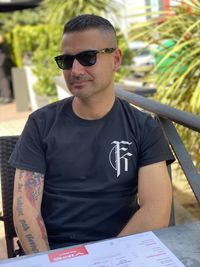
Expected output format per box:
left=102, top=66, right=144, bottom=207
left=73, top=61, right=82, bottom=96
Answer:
left=118, top=161, right=172, bottom=236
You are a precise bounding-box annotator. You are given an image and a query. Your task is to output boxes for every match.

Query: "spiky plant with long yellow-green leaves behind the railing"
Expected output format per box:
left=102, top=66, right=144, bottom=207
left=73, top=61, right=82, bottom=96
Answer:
left=129, top=0, right=200, bottom=166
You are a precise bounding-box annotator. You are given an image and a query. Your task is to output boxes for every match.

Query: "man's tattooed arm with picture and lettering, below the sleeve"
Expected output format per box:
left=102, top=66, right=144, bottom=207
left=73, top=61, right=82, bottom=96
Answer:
left=13, top=169, right=49, bottom=254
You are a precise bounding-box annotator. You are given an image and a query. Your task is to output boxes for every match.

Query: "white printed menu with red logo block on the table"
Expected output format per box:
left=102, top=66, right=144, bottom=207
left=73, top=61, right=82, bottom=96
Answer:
left=0, top=232, right=184, bottom=267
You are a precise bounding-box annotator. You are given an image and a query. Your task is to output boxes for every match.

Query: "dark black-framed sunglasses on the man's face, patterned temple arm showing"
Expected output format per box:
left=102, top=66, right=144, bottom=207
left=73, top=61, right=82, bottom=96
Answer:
left=54, top=48, right=116, bottom=70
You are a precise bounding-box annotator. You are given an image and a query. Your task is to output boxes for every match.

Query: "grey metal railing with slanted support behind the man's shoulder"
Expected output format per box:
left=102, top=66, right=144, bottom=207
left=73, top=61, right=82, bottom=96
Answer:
left=116, top=88, right=200, bottom=202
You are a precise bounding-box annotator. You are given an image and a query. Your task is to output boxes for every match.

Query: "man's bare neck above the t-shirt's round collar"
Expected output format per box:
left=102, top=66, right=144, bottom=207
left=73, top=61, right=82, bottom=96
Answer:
left=72, top=94, right=115, bottom=120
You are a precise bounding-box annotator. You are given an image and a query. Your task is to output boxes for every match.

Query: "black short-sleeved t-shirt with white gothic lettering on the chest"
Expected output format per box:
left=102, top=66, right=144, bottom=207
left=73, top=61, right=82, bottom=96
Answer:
left=10, top=98, right=173, bottom=248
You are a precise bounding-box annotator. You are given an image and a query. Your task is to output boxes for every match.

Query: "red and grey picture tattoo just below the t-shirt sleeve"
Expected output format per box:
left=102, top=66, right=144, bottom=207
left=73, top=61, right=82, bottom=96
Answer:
left=25, top=172, right=44, bottom=205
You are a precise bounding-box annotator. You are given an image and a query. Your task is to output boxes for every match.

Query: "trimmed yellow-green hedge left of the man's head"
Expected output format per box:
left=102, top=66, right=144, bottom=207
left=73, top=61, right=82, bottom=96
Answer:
left=8, top=24, right=62, bottom=96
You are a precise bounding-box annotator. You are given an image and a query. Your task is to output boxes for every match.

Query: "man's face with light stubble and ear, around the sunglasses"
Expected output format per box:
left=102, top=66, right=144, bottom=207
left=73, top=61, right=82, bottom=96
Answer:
left=62, top=29, right=121, bottom=99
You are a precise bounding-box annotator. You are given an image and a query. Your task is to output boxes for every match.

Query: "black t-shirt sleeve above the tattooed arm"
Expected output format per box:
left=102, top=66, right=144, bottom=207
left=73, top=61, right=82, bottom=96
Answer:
left=9, top=116, right=46, bottom=174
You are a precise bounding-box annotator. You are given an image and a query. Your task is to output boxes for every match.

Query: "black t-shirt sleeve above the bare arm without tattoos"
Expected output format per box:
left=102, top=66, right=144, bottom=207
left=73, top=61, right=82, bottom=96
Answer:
left=139, top=116, right=174, bottom=167
